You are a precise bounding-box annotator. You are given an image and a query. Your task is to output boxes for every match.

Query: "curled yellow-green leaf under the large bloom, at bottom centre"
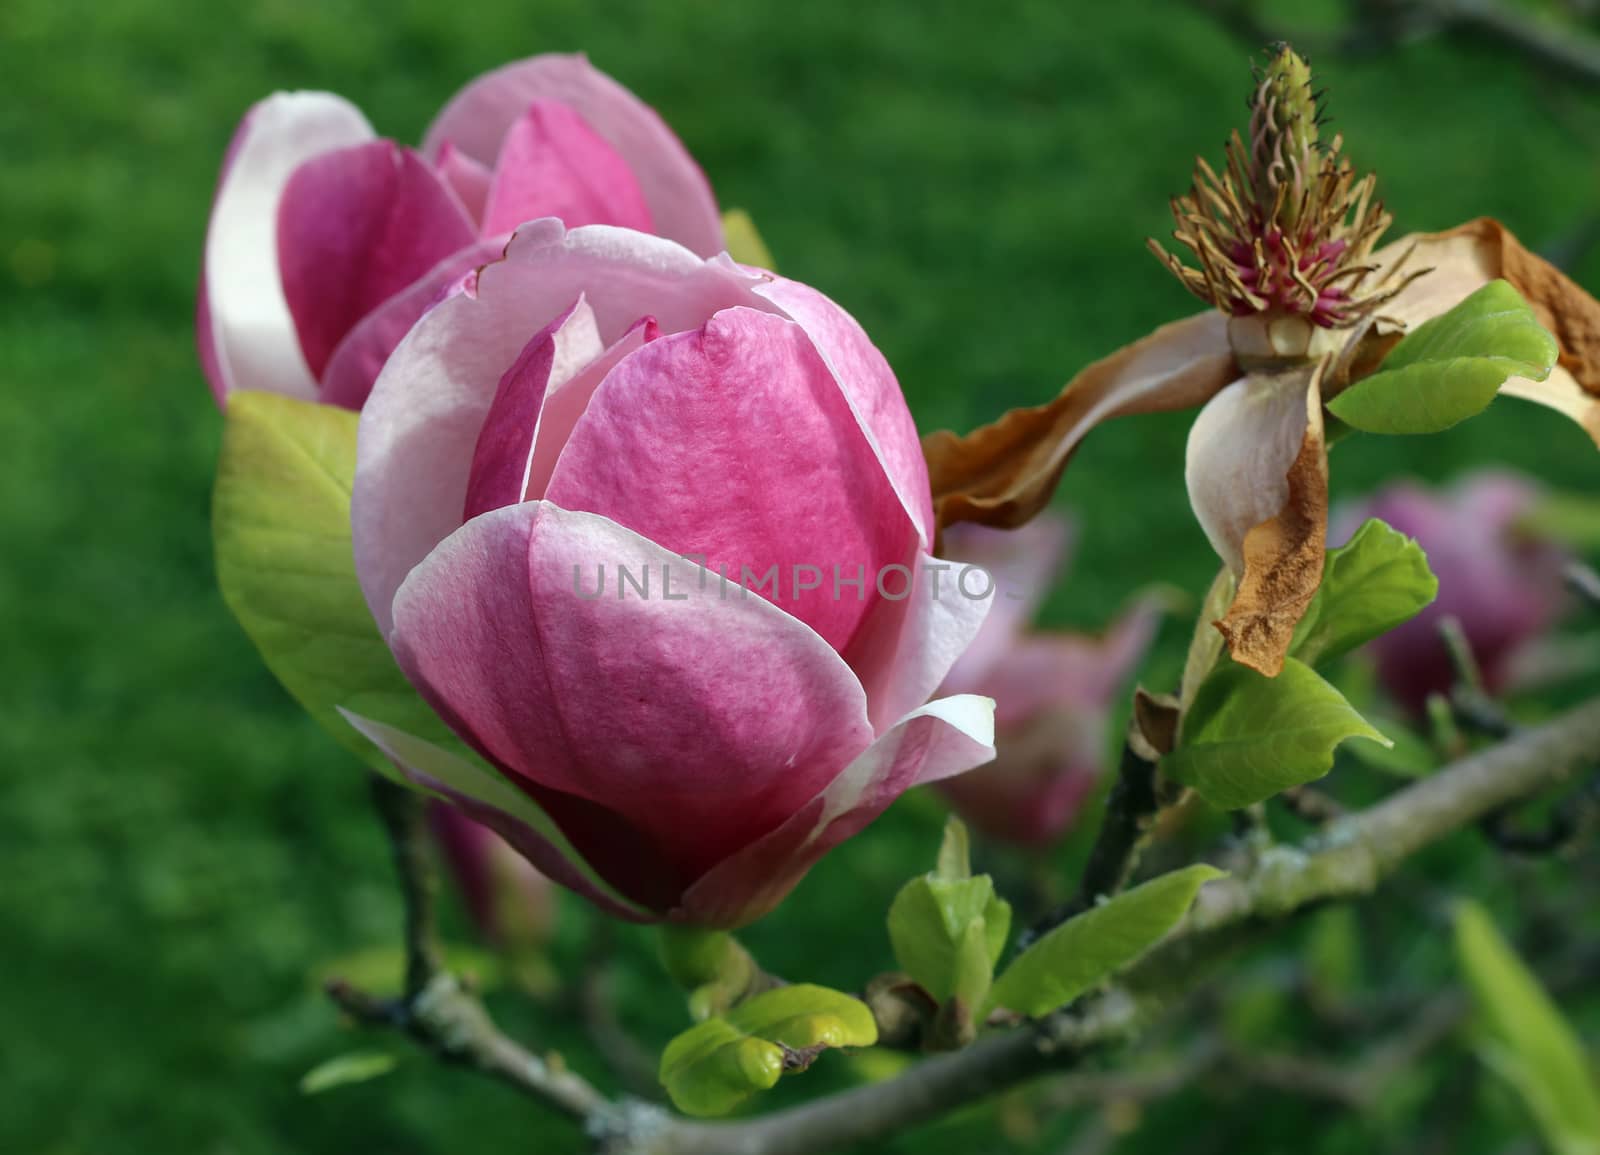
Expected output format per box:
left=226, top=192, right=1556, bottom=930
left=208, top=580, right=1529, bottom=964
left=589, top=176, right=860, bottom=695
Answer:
left=661, top=984, right=878, bottom=1115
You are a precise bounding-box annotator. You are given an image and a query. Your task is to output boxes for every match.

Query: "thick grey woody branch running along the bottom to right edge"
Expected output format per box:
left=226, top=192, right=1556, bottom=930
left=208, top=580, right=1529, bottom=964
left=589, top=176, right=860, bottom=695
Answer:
left=341, top=699, right=1600, bottom=1155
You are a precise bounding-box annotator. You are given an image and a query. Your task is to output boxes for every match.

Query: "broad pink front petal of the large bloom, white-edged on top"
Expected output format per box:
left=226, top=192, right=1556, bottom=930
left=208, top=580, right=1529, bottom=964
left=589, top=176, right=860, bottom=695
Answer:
left=392, top=502, right=872, bottom=902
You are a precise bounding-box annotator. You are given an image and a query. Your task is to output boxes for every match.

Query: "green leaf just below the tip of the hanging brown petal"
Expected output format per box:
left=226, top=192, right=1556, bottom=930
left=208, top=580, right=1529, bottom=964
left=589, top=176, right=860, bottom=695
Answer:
left=1162, top=657, right=1389, bottom=809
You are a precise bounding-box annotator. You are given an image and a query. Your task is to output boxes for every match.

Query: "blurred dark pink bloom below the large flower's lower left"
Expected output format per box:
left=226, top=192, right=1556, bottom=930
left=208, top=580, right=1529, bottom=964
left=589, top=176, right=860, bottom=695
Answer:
left=427, top=803, right=555, bottom=949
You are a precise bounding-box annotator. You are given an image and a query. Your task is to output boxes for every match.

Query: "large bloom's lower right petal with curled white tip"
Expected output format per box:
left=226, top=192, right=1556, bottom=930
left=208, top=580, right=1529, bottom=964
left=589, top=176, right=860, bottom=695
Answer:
left=672, top=694, right=995, bottom=926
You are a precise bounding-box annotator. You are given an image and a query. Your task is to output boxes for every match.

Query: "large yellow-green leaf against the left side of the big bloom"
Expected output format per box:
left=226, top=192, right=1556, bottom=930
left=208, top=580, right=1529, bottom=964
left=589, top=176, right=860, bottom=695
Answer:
left=211, top=392, right=467, bottom=777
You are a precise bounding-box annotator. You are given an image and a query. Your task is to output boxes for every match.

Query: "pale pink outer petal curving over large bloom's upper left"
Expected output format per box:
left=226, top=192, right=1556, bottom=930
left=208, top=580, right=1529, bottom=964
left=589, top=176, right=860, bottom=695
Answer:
left=350, top=221, right=758, bottom=633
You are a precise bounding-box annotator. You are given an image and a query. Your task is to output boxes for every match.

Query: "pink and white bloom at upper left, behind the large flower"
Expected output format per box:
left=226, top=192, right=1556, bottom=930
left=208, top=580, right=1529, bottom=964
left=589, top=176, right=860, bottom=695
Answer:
left=197, top=54, right=723, bottom=410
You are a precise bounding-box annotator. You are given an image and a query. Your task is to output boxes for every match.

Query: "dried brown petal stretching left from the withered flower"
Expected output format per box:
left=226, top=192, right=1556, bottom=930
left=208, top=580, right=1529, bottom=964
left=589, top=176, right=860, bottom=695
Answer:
left=922, top=312, right=1238, bottom=528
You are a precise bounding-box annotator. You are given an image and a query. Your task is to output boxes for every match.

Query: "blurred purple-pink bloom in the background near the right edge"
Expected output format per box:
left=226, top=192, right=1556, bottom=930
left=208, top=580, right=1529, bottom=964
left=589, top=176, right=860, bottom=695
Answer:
left=1347, top=470, right=1568, bottom=713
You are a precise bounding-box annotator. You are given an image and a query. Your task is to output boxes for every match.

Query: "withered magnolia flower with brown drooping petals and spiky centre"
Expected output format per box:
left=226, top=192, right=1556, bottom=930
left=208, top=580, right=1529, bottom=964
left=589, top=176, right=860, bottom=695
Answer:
left=925, top=48, right=1600, bottom=675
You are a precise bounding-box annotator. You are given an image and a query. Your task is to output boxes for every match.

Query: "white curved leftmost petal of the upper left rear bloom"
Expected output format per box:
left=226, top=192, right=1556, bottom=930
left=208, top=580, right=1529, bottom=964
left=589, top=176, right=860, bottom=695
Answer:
left=195, top=93, right=373, bottom=402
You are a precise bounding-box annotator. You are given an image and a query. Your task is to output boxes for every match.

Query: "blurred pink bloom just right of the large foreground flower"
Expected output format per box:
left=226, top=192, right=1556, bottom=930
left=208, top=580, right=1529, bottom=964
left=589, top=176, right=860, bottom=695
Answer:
left=939, top=514, right=1160, bottom=846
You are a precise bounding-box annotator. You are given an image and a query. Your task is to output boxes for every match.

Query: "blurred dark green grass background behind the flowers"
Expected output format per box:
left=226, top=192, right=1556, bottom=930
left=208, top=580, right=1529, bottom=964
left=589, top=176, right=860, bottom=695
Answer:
left=0, top=0, right=1600, bottom=1155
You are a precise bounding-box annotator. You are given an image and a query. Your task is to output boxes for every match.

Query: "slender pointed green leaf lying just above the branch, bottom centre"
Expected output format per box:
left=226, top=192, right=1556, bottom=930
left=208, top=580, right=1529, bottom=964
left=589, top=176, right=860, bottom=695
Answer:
left=989, top=864, right=1224, bottom=1017
